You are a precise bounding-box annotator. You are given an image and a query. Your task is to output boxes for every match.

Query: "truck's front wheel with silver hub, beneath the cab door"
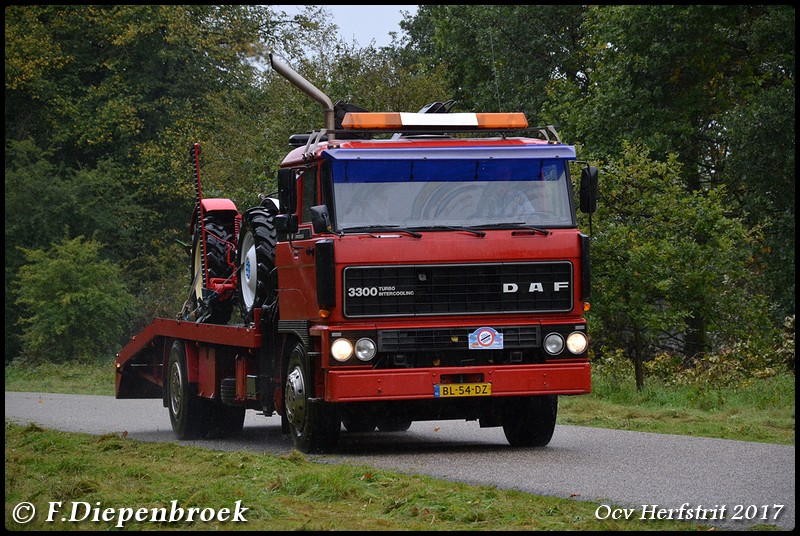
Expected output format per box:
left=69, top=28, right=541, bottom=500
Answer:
left=283, top=343, right=341, bottom=453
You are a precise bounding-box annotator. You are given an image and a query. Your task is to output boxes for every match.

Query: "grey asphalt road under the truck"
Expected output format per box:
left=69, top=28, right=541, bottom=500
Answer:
left=5, top=392, right=795, bottom=530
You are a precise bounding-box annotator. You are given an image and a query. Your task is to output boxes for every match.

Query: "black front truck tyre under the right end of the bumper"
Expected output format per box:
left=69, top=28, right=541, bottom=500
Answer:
left=501, top=395, right=558, bottom=447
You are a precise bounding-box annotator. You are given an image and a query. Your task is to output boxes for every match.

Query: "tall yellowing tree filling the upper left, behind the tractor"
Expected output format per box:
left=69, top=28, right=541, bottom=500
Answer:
left=4, top=5, right=318, bottom=358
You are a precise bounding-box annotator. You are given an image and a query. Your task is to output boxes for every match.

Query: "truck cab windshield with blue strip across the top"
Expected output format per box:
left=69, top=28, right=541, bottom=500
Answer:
left=331, top=158, right=575, bottom=231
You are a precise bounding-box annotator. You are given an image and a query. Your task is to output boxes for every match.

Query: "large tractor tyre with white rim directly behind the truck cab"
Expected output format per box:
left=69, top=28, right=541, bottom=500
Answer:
left=237, top=207, right=278, bottom=324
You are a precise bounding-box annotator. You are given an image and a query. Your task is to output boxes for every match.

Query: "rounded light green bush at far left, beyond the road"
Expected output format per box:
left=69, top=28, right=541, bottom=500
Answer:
left=15, top=236, right=133, bottom=363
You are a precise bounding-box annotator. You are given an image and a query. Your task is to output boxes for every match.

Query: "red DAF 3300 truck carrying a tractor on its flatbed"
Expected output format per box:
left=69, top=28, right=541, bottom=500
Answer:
left=115, top=53, right=597, bottom=452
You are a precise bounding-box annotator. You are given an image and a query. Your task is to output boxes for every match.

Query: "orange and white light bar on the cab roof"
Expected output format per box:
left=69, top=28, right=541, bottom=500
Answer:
left=342, top=112, right=528, bottom=130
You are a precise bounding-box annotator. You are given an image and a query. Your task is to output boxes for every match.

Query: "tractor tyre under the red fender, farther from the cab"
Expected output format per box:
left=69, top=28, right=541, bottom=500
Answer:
left=191, top=214, right=234, bottom=324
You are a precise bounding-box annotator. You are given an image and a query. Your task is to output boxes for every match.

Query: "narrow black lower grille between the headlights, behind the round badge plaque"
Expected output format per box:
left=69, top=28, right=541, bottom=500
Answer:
left=378, top=326, right=540, bottom=352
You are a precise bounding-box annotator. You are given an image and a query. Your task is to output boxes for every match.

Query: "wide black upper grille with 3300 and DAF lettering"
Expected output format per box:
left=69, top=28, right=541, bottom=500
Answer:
left=344, top=261, right=573, bottom=318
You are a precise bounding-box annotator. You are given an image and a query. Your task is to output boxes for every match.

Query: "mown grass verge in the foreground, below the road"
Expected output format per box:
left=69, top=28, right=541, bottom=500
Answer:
left=5, top=422, right=732, bottom=531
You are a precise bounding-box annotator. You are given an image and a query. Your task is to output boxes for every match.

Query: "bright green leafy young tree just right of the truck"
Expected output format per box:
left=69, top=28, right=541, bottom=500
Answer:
left=590, top=143, right=772, bottom=388
